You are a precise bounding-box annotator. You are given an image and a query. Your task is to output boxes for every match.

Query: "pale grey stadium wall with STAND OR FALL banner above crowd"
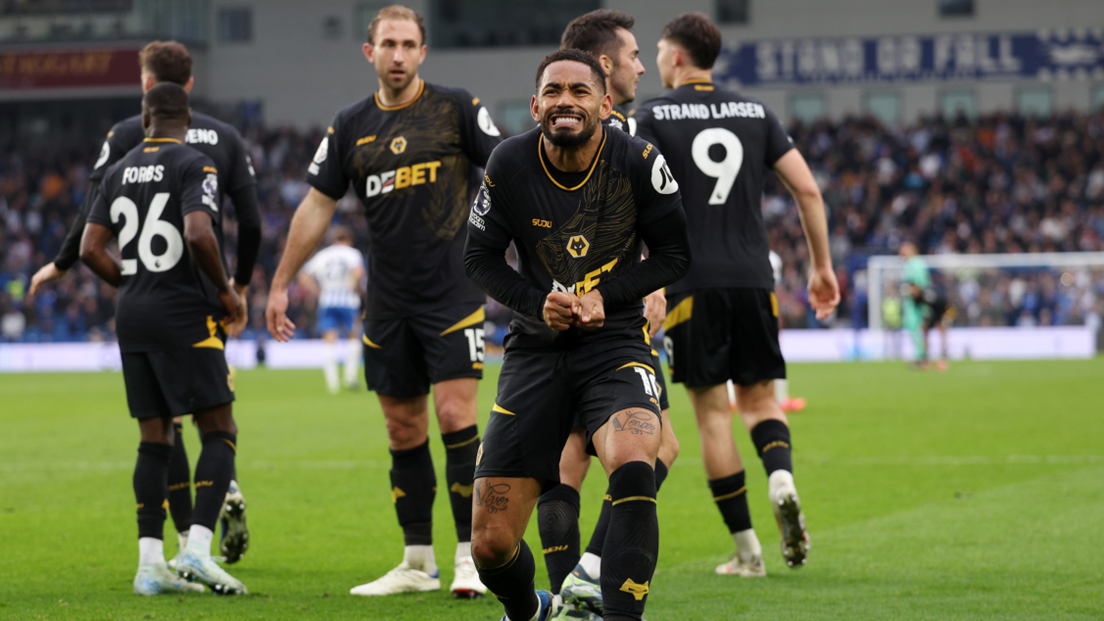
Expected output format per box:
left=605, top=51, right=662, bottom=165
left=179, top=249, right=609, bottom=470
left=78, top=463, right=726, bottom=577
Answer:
left=195, top=0, right=1104, bottom=127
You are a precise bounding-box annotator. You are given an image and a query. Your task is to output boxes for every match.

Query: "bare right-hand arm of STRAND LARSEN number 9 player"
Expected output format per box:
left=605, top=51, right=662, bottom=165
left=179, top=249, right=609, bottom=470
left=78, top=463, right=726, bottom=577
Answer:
left=774, top=149, right=839, bottom=319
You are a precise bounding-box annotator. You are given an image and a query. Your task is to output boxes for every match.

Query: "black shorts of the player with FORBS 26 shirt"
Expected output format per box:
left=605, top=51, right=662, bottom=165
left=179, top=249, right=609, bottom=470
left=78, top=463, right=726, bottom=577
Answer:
left=123, top=341, right=234, bottom=420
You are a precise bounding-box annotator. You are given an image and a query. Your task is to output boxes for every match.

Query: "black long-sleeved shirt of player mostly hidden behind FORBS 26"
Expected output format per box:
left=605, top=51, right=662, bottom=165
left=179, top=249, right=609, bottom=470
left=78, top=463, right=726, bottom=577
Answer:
left=54, top=113, right=261, bottom=284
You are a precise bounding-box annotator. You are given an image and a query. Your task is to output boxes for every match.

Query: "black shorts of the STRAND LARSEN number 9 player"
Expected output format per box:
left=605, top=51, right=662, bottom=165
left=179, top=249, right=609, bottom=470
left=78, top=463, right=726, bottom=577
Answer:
left=664, top=287, right=786, bottom=388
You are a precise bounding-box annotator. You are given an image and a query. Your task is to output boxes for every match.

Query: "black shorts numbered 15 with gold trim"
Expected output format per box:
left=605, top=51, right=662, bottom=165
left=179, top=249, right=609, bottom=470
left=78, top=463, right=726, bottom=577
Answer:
left=363, top=304, right=486, bottom=399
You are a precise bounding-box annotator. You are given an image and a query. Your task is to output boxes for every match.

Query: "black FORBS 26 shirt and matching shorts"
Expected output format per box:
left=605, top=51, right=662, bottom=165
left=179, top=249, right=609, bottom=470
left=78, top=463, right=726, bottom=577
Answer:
left=88, top=138, right=234, bottom=419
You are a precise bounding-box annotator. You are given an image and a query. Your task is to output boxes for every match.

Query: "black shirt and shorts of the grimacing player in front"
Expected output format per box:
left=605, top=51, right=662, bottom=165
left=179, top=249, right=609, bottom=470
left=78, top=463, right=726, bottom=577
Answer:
left=465, top=128, right=690, bottom=483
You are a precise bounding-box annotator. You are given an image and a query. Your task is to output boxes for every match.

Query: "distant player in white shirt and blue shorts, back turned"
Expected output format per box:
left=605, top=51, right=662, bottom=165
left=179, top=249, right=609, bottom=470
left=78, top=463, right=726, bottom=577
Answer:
left=299, top=227, right=364, bottom=394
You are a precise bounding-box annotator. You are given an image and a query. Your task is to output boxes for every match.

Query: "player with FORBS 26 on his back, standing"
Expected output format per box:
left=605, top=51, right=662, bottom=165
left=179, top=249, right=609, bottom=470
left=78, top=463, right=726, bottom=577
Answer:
left=81, top=82, right=246, bottom=596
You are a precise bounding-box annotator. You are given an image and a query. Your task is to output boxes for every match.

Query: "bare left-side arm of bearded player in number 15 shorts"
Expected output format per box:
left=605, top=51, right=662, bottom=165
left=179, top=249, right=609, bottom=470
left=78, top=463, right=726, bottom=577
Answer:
left=265, top=188, right=338, bottom=341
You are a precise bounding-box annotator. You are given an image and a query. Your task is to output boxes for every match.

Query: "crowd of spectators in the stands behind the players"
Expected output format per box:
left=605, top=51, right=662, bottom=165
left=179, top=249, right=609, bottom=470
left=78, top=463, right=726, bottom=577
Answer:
left=0, top=112, right=1104, bottom=341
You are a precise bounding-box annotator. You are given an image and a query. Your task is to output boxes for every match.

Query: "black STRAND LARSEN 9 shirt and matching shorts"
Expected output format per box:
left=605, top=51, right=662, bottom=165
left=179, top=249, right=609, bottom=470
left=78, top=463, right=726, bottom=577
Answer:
left=634, top=80, right=794, bottom=387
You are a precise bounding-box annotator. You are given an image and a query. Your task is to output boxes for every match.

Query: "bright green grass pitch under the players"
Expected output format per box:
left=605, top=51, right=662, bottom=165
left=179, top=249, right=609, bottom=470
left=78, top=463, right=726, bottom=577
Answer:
left=0, top=358, right=1104, bottom=621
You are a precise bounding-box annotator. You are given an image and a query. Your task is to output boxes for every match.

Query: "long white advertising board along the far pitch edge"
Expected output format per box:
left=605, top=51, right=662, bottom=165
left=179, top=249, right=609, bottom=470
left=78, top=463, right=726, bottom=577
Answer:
left=0, top=327, right=1096, bottom=372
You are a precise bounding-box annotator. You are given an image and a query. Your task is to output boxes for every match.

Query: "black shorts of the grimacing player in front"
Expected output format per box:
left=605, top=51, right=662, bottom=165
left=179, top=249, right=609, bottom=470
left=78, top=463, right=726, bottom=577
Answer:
left=476, top=334, right=661, bottom=487
